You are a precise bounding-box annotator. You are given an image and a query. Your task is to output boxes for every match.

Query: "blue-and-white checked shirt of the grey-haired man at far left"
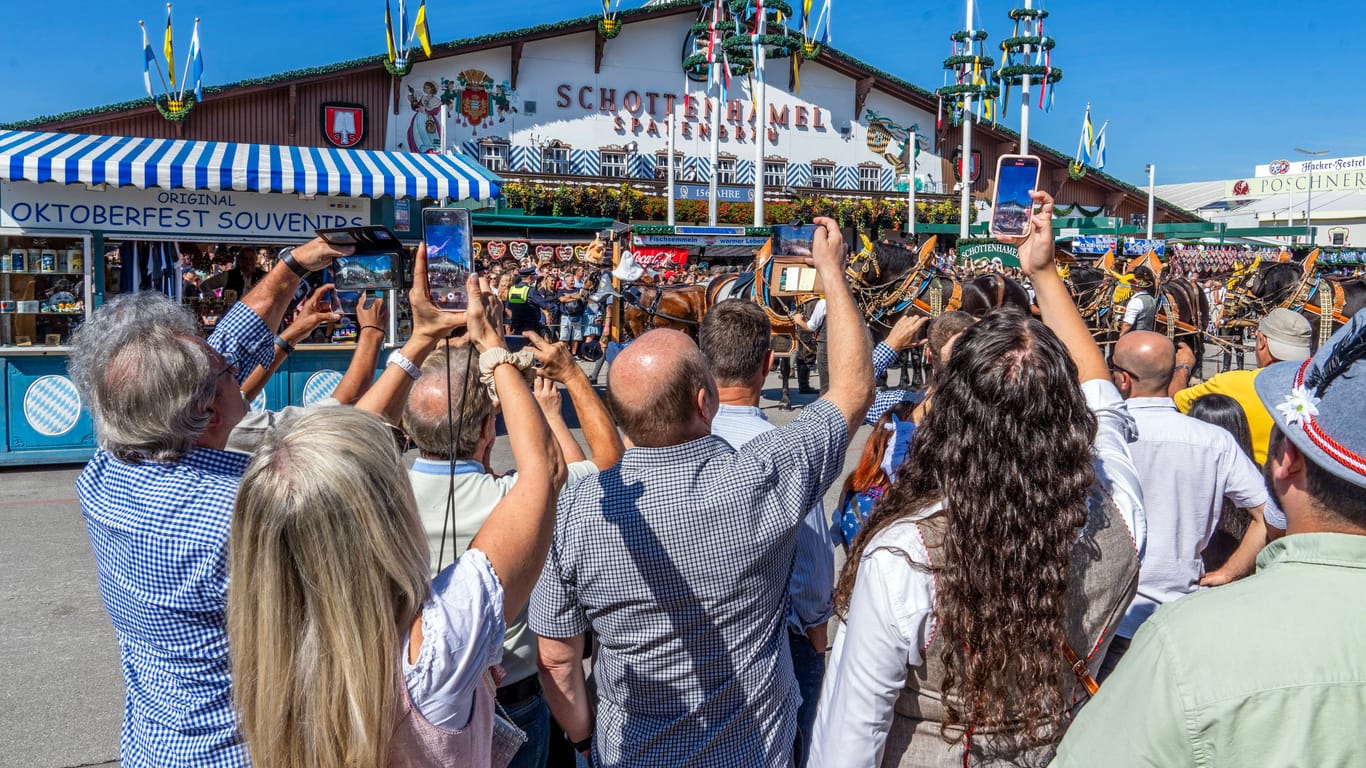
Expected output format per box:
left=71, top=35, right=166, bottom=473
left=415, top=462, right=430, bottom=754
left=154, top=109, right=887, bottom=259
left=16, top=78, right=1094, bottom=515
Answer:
left=76, top=303, right=275, bottom=768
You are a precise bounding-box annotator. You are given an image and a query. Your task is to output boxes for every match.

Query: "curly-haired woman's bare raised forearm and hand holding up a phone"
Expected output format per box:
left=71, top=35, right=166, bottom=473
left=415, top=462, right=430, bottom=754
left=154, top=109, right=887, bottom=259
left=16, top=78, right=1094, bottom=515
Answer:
left=1001, top=191, right=1111, bottom=381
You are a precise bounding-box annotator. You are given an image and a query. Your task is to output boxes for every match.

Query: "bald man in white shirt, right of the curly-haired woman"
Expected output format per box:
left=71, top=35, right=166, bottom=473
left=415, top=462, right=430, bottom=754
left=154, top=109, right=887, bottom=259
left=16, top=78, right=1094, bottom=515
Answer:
left=1100, top=331, right=1285, bottom=679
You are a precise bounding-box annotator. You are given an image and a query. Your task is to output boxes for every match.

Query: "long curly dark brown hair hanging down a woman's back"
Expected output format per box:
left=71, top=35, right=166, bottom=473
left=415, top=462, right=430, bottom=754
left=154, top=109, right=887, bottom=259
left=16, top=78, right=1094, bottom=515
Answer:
left=835, top=310, right=1096, bottom=746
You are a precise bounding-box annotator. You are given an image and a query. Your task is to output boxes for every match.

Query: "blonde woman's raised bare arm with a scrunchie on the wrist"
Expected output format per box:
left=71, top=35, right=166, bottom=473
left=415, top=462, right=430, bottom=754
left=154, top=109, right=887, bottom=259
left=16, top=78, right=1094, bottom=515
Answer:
left=469, top=284, right=566, bottom=616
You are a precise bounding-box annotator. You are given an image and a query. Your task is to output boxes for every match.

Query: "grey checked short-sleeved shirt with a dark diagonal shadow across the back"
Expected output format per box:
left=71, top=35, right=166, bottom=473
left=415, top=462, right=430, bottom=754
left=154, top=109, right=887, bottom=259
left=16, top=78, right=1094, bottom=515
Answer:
left=530, top=400, right=848, bottom=768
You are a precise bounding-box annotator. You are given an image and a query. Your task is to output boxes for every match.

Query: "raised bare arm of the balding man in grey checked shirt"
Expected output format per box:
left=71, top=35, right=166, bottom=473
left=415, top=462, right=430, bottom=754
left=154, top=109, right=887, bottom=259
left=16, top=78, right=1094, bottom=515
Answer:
left=811, top=217, right=873, bottom=435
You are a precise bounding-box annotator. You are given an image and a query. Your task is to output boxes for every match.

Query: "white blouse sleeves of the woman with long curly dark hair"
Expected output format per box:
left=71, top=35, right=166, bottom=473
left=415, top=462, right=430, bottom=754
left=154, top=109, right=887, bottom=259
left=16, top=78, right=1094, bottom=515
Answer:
left=810, top=379, right=1146, bottom=768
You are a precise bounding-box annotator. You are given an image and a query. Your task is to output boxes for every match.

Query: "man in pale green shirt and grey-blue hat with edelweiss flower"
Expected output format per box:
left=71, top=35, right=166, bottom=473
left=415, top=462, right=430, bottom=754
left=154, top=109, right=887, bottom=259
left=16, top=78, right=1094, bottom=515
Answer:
left=1053, top=314, right=1366, bottom=768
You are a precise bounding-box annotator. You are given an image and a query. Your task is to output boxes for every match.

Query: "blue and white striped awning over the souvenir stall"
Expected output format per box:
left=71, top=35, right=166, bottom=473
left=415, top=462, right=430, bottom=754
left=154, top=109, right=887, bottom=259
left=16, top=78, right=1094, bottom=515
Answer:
left=0, top=130, right=503, bottom=200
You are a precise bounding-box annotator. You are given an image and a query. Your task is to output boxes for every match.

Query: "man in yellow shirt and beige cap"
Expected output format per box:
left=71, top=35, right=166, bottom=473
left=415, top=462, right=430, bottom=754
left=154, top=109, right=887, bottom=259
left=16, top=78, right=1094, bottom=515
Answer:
left=1171, top=307, right=1314, bottom=465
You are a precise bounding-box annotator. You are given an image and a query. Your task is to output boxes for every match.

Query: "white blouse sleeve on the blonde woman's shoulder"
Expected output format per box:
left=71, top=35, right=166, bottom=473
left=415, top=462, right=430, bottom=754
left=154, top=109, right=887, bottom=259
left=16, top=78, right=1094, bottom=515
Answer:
left=403, top=549, right=507, bottom=730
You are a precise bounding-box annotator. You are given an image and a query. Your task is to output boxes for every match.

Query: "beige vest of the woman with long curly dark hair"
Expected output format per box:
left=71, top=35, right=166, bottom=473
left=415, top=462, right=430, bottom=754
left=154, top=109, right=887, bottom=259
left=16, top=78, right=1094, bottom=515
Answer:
left=882, top=488, right=1138, bottom=768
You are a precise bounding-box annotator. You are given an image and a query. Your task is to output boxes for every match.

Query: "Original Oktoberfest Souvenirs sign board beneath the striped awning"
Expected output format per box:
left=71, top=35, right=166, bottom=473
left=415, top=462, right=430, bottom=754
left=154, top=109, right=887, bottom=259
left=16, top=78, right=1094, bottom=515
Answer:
left=0, top=182, right=370, bottom=239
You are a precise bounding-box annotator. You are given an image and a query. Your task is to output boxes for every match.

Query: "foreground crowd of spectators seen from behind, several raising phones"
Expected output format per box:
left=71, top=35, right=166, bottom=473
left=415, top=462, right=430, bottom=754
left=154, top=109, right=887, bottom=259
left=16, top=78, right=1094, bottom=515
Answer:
left=70, top=193, right=1366, bottom=768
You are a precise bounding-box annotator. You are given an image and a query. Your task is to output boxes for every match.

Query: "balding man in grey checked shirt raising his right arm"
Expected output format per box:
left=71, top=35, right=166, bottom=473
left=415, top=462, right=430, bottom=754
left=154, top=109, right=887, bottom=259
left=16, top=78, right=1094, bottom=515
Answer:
left=530, top=219, right=873, bottom=768
